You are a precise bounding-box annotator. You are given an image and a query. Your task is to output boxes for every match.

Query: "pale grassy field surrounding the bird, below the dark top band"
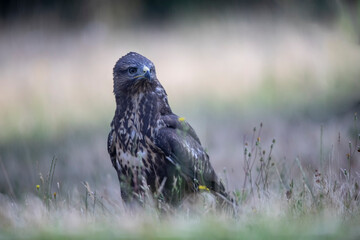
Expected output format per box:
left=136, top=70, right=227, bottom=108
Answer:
left=0, top=7, right=360, bottom=239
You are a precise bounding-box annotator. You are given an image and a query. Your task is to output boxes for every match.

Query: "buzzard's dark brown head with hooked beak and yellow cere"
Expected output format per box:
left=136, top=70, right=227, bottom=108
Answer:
left=113, top=52, right=158, bottom=96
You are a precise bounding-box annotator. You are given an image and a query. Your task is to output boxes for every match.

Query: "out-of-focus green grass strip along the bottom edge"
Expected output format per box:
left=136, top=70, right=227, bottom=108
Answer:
left=2, top=216, right=359, bottom=239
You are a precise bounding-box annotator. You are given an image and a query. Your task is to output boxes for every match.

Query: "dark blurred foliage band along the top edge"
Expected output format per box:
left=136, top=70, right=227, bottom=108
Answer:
left=0, top=0, right=348, bottom=27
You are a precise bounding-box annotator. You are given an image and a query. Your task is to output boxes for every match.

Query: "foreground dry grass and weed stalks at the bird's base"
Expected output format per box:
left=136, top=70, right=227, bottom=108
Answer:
left=0, top=115, right=360, bottom=239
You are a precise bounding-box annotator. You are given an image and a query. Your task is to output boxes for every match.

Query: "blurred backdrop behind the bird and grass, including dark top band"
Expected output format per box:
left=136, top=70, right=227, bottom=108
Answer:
left=0, top=0, right=360, bottom=201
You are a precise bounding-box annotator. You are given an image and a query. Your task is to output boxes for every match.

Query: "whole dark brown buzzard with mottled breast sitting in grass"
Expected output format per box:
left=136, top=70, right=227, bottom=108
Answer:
left=107, top=52, right=227, bottom=204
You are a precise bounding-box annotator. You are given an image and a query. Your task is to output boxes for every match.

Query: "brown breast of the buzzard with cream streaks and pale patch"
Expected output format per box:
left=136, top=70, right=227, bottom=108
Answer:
left=115, top=94, right=163, bottom=171
